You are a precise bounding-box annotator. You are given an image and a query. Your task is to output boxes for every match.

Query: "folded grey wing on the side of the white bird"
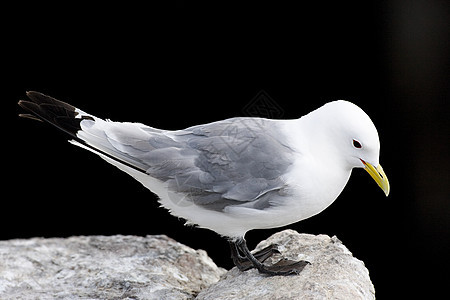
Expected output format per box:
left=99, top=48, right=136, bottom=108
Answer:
left=107, top=118, right=292, bottom=210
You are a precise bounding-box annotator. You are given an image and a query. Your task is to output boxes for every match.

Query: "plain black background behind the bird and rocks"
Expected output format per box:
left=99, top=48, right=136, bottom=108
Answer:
left=0, top=0, right=450, bottom=299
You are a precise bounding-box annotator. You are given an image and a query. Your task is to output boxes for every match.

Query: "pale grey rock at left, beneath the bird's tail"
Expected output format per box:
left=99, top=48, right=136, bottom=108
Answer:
left=0, top=236, right=225, bottom=299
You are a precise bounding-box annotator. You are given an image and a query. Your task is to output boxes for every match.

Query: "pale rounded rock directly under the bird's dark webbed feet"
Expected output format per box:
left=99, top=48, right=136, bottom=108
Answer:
left=197, top=230, right=375, bottom=300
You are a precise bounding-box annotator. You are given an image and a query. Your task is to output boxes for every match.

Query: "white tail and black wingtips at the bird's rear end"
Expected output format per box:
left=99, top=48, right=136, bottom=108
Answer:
left=18, top=91, right=146, bottom=173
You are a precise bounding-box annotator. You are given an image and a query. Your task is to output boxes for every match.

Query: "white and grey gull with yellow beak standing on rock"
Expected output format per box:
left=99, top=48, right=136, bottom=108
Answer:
left=18, top=91, right=390, bottom=276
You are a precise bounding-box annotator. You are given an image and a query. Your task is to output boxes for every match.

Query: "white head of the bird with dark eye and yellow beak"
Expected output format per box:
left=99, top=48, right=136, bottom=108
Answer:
left=313, top=100, right=390, bottom=196
